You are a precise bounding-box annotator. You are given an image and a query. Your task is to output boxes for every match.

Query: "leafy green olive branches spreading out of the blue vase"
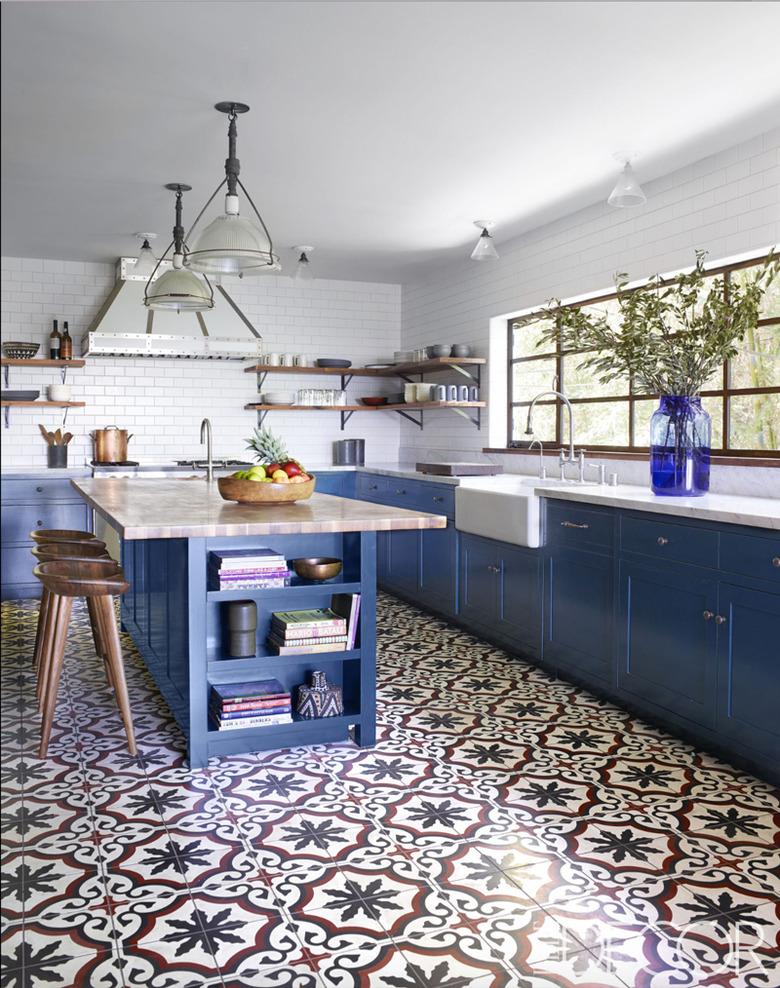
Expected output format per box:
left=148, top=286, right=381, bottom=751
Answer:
left=538, top=250, right=780, bottom=397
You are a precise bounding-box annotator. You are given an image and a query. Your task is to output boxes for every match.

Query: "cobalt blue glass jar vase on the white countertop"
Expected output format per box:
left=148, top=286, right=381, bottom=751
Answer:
left=650, top=395, right=712, bottom=497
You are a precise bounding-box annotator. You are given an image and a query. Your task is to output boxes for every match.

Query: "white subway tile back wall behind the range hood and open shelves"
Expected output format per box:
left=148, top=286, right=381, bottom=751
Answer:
left=1, top=266, right=401, bottom=468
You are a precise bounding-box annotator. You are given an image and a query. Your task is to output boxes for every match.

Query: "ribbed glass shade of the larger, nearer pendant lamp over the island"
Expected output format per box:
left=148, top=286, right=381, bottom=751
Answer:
left=184, top=197, right=282, bottom=274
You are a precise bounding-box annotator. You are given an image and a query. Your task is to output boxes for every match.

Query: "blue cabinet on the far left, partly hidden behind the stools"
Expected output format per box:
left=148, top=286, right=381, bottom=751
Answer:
left=0, top=476, right=92, bottom=600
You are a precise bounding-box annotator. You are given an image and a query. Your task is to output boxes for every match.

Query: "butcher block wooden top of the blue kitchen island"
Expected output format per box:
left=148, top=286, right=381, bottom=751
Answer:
left=71, top=478, right=447, bottom=541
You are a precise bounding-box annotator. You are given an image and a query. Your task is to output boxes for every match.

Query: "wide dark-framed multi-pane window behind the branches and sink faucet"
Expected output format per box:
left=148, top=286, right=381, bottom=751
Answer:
left=508, top=258, right=780, bottom=458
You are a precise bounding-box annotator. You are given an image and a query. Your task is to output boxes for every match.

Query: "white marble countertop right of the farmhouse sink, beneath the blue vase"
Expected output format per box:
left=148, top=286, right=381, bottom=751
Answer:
left=526, top=477, right=780, bottom=529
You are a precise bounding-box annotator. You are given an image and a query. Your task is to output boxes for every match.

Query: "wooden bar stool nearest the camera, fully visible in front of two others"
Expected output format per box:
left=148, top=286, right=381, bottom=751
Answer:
left=33, top=559, right=137, bottom=758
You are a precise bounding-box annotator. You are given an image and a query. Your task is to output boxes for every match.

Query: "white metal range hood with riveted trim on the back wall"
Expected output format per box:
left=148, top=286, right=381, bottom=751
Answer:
left=81, top=257, right=261, bottom=360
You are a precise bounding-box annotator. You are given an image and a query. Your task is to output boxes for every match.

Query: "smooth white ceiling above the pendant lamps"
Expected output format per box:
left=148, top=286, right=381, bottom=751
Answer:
left=1, top=0, right=780, bottom=281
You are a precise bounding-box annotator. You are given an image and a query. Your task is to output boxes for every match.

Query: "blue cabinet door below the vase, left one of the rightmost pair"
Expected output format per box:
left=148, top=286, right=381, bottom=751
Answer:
left=618, top=560, right=717, bottom=727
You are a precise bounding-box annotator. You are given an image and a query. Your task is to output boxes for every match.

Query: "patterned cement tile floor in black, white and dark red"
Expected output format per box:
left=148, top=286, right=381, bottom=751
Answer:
left=0, top=596, right=780, bottom=988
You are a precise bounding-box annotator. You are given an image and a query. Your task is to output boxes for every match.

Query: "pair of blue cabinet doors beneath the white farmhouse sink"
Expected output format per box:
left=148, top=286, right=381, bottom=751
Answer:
left=459, top=534, right=542, bottom=658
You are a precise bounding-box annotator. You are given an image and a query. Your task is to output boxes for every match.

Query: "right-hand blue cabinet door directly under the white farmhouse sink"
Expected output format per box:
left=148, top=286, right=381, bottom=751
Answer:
left=498, top=547, right=542, bottom=655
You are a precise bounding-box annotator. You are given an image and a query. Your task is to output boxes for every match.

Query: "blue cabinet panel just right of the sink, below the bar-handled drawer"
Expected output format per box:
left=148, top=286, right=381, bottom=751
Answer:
left=544, top=548, right=613, bottom=682
